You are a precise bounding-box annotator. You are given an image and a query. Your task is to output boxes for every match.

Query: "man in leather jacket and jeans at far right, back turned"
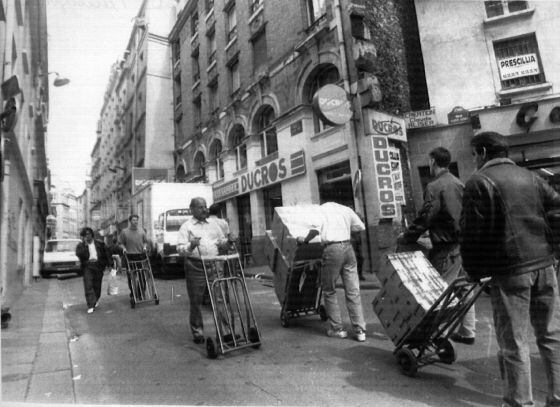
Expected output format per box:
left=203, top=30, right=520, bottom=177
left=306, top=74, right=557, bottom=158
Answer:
left=461, top=132, right=560, bottom=406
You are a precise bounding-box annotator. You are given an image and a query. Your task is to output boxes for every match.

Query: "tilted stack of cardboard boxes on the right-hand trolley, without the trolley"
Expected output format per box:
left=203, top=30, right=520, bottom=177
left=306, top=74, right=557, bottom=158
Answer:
left=373, top=251, right=447, bottom=345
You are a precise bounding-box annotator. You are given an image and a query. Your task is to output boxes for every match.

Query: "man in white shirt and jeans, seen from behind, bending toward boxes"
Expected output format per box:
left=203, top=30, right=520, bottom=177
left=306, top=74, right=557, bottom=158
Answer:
left=297, top=202, right=366, bottom=342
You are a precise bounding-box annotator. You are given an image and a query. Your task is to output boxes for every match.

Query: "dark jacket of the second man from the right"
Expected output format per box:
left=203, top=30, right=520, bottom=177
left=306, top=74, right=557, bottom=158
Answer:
left=404, top=169, right=464, bottom=247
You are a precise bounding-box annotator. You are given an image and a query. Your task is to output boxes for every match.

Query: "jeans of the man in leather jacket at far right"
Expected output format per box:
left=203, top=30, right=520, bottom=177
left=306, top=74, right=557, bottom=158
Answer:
left=491, top=265, right=560, bottom=406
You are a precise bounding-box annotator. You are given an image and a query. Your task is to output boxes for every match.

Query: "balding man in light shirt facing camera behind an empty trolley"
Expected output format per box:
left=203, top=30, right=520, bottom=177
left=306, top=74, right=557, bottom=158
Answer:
left=177, top=198, right=233, bottom=343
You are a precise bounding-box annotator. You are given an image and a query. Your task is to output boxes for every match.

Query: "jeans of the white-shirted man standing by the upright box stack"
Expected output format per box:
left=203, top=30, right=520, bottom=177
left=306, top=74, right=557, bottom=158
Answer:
left=321, top=242, right=366, bottom=331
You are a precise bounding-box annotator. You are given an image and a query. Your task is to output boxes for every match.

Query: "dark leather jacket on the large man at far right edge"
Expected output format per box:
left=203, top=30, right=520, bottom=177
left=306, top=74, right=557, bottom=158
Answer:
left=461, top=158, right=560, bottom=279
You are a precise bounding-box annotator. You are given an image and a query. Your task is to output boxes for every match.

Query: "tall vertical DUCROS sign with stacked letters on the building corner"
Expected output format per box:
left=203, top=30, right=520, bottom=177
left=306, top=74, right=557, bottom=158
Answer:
left=371, top=136, right=397, bottom=218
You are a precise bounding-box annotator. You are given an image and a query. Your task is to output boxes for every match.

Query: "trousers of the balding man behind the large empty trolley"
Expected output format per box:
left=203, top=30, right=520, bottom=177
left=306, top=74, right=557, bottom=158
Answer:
left=185, top=257, right=234, bottom=337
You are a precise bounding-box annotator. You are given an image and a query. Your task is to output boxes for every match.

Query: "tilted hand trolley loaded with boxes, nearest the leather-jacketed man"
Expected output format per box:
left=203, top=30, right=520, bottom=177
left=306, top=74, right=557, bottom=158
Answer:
left=372, top=251, right=489, bottom=376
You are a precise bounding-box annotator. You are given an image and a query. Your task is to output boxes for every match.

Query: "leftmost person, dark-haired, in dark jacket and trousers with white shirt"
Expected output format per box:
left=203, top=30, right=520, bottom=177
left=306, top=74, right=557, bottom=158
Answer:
left=76, top=227, right=110, bottom=314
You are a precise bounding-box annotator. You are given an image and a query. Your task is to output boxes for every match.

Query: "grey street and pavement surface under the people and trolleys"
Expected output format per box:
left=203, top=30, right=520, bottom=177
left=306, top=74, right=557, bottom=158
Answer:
left=2, top=270, right=546, bottom=406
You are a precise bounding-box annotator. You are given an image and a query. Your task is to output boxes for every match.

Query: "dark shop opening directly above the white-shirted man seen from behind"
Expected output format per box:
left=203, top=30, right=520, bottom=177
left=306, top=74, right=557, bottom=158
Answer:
left=317, top=161, right=355, bottom=209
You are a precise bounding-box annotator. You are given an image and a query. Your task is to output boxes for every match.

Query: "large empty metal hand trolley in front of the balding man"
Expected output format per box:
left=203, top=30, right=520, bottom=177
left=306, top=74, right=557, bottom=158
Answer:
left=199, top=248, right=261, bottom=359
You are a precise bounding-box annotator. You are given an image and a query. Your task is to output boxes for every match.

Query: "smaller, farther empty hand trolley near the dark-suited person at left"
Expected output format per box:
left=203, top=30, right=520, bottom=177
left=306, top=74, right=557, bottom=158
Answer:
left=124, top=252, right=159, bottom=308
